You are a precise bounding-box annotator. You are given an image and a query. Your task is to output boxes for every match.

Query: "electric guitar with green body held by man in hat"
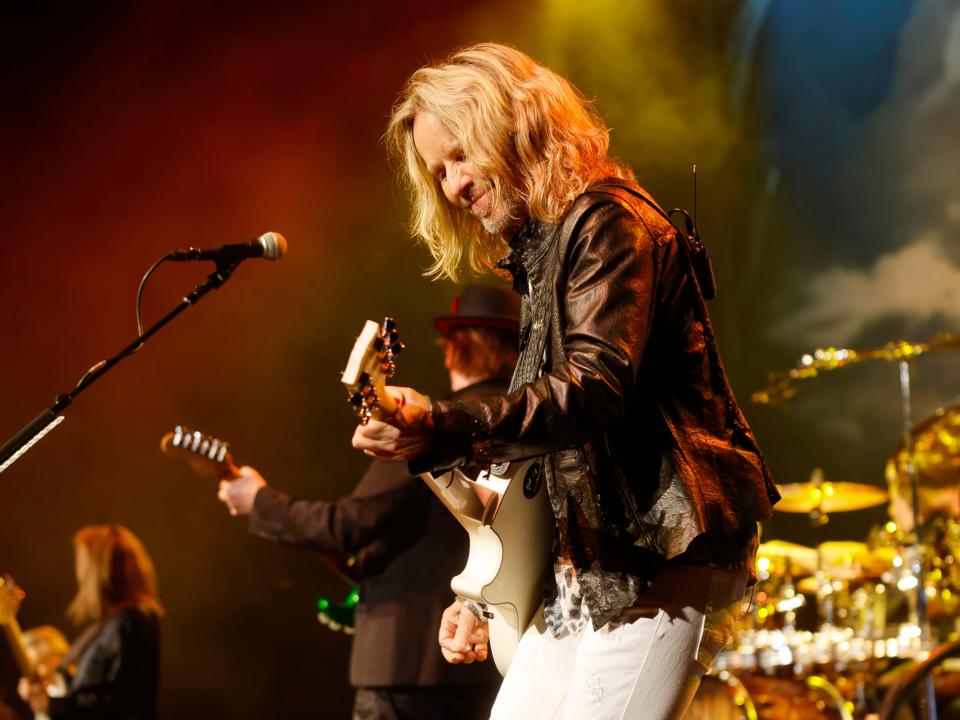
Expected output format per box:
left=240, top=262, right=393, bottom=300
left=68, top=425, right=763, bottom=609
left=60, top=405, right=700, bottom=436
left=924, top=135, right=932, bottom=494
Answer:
left=160, top=425, right=360, bottom=635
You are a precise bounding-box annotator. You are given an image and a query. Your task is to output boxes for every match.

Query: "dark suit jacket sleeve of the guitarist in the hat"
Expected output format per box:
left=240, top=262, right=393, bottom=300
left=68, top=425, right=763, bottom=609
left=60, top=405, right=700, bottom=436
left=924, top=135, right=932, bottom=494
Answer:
left=250, top=460, right=424, bottom=554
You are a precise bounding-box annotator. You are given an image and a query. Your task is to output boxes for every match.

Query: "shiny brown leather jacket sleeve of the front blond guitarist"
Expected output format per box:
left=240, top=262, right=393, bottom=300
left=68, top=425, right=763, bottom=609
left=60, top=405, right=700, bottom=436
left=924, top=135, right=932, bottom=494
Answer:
left=424, top=202, right=672, bottom=469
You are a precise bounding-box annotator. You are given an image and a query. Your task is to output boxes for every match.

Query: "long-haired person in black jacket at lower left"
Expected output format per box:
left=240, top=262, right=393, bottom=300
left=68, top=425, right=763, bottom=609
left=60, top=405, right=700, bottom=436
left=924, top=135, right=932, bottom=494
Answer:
left=18, top=525, right=163, bottom=720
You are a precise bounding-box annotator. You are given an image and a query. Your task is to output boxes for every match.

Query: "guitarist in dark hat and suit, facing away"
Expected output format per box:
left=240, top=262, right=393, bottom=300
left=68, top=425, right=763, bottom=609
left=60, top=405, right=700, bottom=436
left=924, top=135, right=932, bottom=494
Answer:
left=219, top=285, right=519, bottom=720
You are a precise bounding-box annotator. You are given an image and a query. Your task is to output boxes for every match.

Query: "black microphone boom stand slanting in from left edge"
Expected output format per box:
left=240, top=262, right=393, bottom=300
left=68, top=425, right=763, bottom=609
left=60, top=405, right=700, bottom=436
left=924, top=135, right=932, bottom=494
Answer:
left=0, top=260, right=241, bottom=473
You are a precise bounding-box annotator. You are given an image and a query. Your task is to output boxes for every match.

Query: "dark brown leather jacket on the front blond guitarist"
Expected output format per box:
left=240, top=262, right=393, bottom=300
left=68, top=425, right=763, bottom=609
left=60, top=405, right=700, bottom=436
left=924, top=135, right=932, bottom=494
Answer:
left=420, top=184, right=779, bottom=628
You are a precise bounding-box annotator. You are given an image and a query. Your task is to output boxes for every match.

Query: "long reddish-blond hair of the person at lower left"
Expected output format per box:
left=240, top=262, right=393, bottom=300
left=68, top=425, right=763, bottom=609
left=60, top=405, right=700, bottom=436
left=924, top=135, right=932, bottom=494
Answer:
left=67, top=525, right=163, bottom=625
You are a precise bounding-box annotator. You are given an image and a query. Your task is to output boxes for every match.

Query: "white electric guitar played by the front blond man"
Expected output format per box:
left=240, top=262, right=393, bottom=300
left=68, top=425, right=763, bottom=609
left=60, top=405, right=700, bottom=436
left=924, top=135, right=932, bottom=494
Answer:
left=342, top=318, right=553, bottom=675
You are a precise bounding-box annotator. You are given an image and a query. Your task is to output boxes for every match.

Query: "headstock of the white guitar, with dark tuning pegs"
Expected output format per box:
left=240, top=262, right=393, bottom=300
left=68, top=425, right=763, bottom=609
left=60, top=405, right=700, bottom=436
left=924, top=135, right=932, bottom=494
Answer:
left=340, top=317, right=404, bottom=425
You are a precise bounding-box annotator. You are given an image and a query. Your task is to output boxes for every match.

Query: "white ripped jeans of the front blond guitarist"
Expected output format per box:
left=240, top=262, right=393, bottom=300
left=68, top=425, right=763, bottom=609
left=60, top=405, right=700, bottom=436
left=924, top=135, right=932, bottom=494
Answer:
left=490, top=566, right=747, bottom=720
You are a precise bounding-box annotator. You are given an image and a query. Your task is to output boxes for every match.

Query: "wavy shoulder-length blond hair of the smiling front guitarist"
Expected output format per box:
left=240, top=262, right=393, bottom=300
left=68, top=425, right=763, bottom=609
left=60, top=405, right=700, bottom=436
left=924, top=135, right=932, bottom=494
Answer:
left=386, top=43, right=633, bottom=280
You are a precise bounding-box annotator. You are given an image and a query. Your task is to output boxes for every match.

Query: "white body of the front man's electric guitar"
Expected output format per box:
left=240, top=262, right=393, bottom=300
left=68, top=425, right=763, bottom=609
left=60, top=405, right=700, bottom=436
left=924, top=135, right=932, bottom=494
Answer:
left=421, top=458, right=553, bottom=675
